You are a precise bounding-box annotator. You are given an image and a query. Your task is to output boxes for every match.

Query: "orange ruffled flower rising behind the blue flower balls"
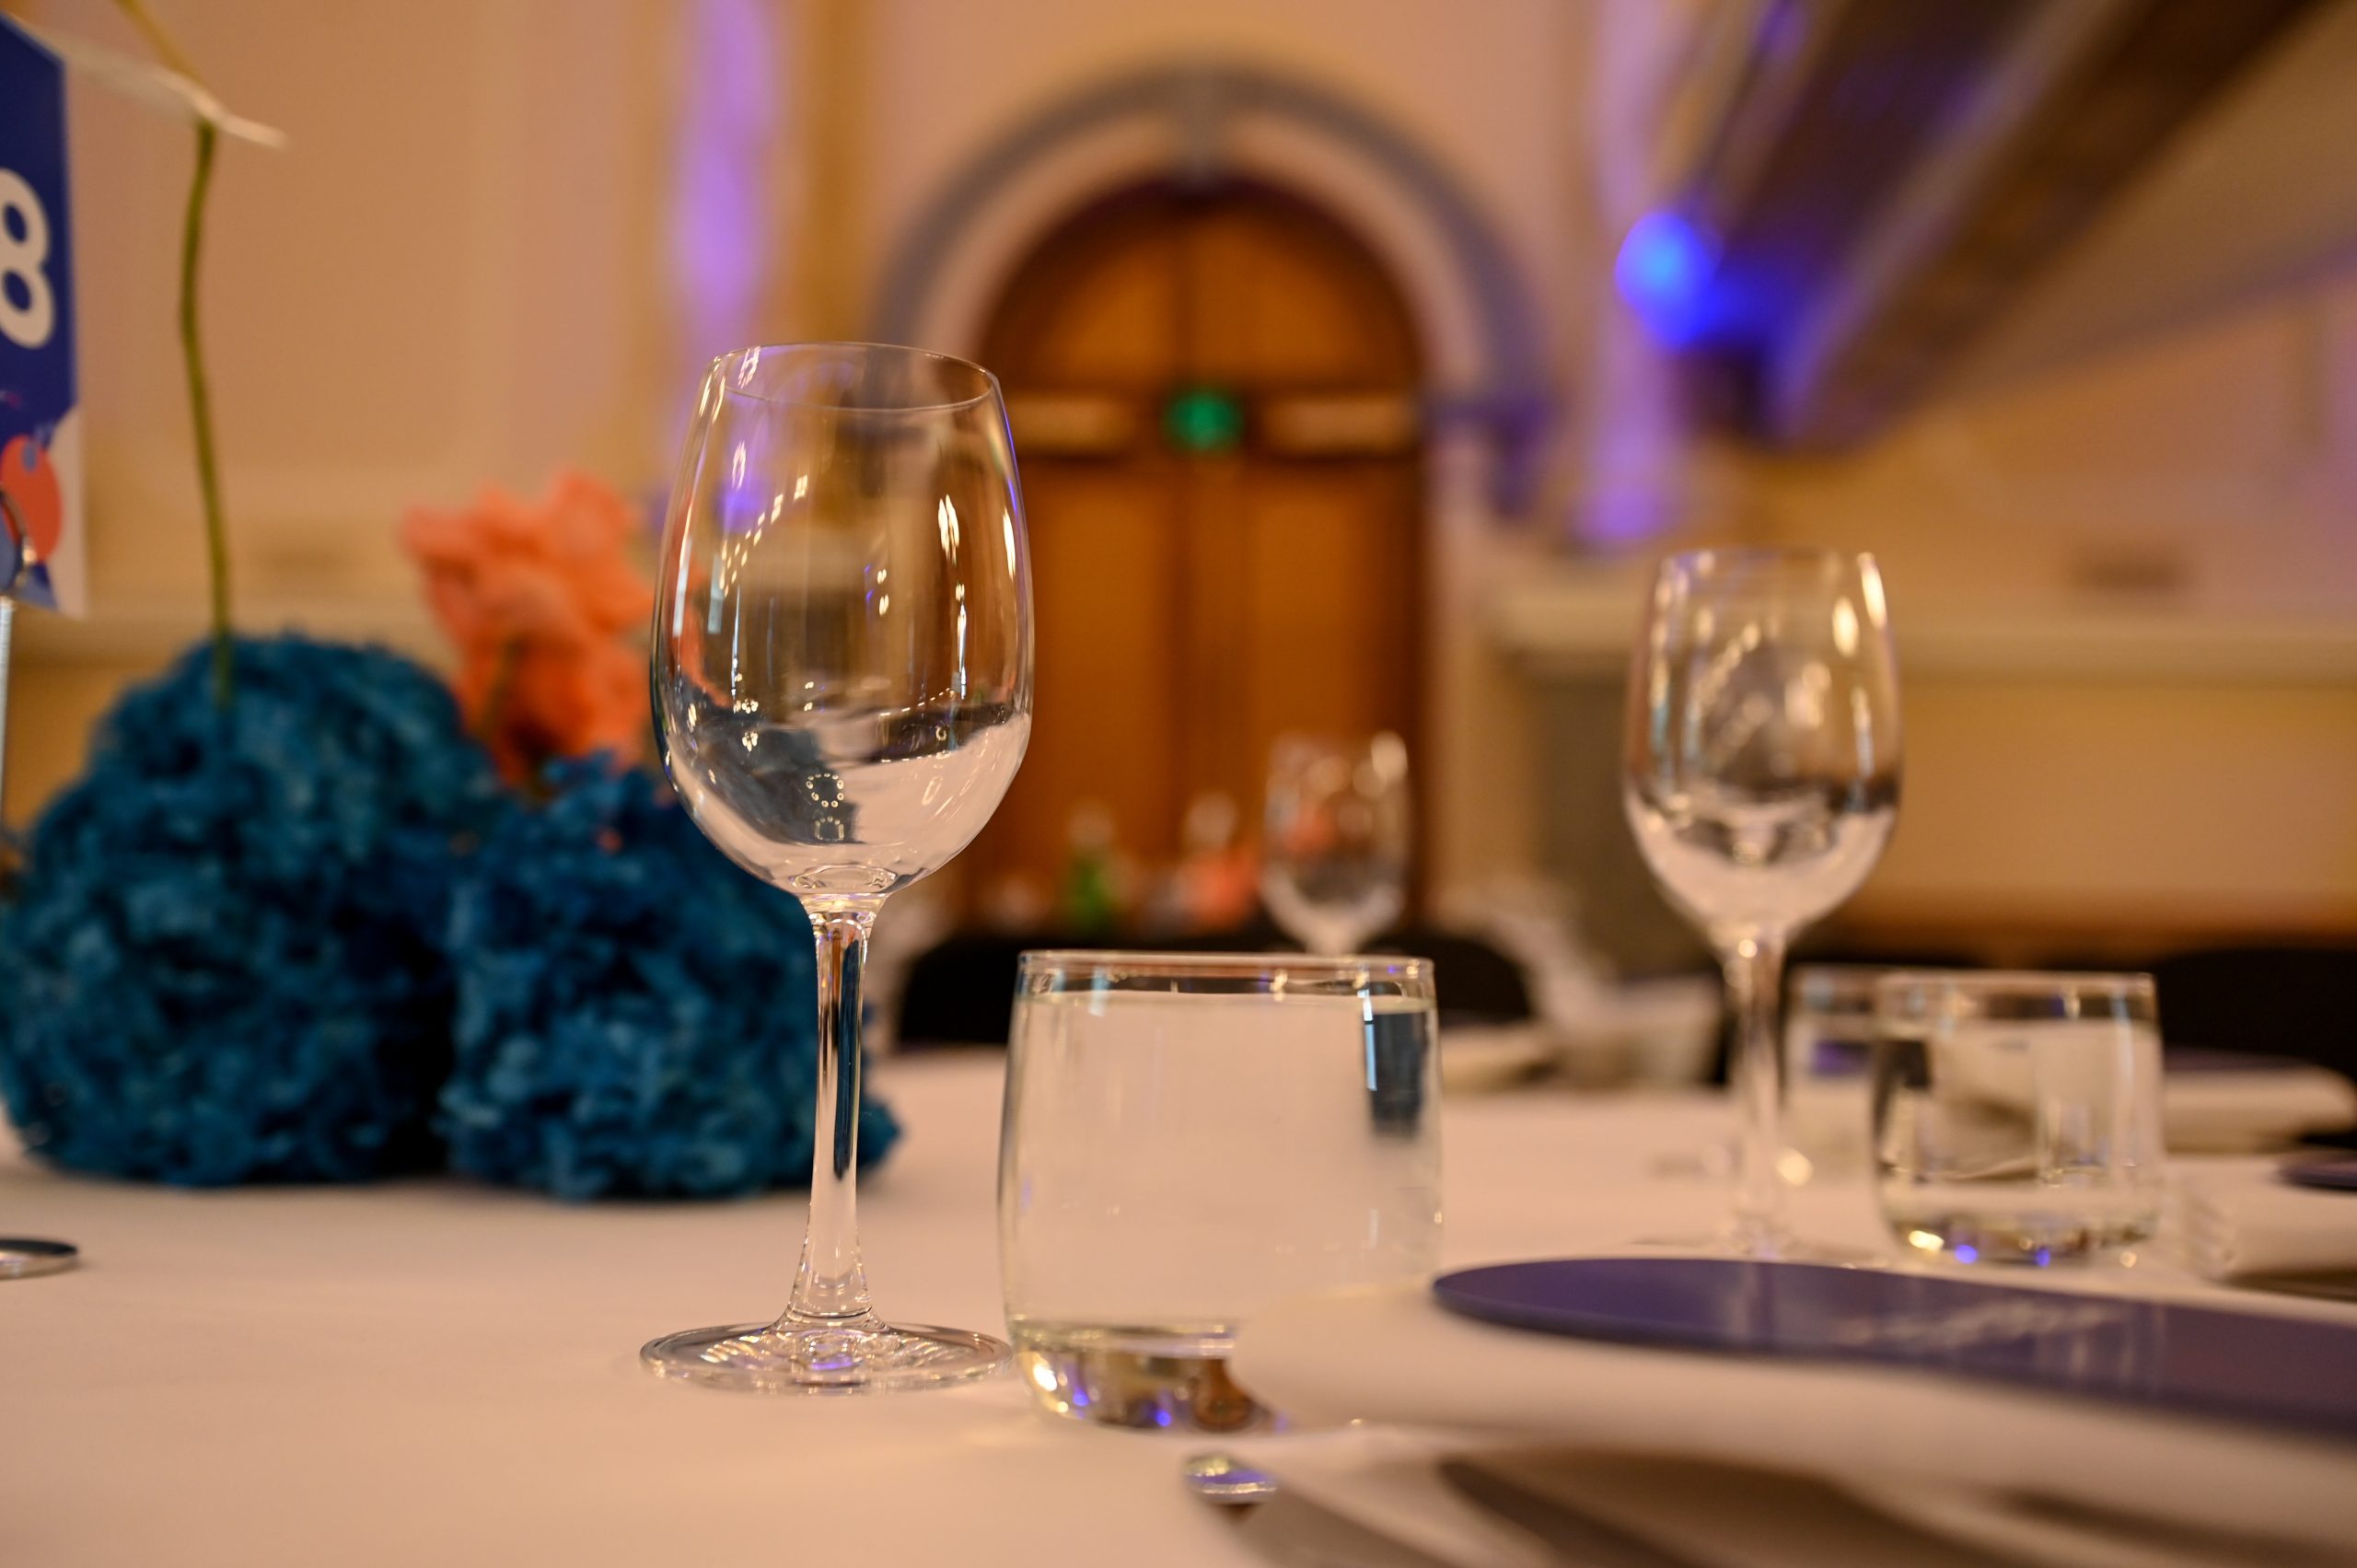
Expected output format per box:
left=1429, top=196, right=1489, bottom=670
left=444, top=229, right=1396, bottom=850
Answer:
left=401, top=474, right=653, bottom=783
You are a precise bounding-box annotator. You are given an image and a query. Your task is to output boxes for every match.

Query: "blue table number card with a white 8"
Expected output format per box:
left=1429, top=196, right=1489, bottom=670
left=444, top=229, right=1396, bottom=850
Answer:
left=0, top=17, right=83, bottom=615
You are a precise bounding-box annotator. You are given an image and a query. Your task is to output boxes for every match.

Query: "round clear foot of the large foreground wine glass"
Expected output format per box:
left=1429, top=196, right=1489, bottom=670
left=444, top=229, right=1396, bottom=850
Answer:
left=639, top=1318, right=1011, bottom=1393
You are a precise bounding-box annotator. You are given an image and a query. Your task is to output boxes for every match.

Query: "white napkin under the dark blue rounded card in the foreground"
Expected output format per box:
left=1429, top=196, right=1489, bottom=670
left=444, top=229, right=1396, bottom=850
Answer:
left=1233, top=1285, right=2357, bottom=1544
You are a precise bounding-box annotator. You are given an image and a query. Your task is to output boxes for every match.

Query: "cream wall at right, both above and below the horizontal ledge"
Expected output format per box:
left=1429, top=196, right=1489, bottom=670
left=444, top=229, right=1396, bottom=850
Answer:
left=1742, top=281, right=2357, bottom=936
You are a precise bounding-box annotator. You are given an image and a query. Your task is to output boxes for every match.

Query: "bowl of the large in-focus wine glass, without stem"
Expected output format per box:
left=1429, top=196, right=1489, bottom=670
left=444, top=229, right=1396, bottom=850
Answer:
left=656, top=344, right=1030, bottom=899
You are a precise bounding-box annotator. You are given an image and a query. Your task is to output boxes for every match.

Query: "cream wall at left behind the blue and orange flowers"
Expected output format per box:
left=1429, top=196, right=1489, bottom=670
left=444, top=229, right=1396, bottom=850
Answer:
left=7, top=0, right=688, bottom=820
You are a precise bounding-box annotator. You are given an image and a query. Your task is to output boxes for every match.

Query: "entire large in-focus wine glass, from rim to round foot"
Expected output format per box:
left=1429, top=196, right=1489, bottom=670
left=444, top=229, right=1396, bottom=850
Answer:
left=644, top=344, right=1032, bottom=1391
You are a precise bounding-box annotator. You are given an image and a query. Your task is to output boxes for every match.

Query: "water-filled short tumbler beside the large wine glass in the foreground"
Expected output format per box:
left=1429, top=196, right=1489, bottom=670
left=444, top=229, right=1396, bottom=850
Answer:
left=999, top=953, right=1440, bottom=1431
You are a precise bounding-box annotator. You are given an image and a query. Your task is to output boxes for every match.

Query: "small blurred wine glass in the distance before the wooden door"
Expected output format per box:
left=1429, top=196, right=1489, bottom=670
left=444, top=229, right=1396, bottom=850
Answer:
left=1261, top=731, right=1410, bottom=955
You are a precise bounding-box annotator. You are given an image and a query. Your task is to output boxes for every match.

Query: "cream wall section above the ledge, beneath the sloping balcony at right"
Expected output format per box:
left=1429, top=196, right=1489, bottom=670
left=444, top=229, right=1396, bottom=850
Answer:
left=1747, top=278, right=2357, bottom=615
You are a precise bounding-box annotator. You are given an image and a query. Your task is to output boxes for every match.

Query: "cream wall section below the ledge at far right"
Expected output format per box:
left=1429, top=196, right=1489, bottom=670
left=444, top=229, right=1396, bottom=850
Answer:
left=1851, top=679, right=2357, bottom=947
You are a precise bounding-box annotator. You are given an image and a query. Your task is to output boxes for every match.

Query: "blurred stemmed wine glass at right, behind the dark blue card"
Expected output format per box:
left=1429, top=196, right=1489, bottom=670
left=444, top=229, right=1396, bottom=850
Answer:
left=1621, top=550, right=1899, bottom=1257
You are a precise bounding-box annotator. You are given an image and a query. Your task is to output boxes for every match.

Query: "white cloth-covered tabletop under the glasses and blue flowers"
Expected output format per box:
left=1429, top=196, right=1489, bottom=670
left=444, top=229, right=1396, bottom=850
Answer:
left=0, top=1054, right=2338, bottom=1568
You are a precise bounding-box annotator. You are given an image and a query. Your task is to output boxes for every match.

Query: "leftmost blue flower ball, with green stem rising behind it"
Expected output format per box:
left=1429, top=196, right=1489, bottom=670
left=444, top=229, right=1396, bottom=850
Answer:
left=0, top=636, right=500, bottom=1186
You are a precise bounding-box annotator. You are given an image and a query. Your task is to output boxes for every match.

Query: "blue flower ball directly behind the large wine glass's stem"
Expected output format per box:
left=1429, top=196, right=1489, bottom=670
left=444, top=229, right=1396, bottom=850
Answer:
left=436, top=764, right=898, bottom=1198
